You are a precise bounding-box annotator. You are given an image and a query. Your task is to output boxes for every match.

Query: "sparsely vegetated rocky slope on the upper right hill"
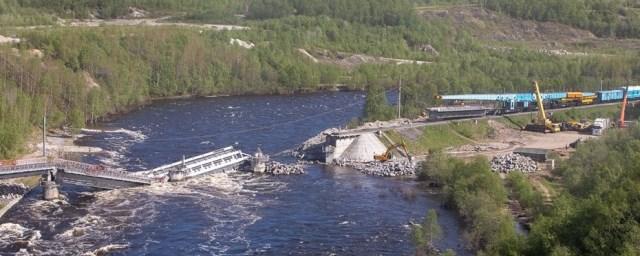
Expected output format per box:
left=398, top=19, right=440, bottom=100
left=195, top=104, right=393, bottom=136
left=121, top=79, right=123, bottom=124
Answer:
left=418, top=5, right=640, bottom=55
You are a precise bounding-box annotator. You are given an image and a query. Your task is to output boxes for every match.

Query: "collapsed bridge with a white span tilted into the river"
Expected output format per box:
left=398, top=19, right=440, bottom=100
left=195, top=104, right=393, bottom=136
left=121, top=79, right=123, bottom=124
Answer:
left=0, top=147, right=251, bottom=200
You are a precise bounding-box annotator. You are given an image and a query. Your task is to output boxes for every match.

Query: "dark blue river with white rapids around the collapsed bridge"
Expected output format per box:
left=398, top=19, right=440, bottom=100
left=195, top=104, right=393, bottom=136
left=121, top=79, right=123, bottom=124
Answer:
left=0, top=92, right=468, bottom=255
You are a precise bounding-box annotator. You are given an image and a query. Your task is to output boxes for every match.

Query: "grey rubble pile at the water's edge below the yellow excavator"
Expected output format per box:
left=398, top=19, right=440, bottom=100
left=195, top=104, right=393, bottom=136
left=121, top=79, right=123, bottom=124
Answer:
left=337, top=161, right=416, bottom=177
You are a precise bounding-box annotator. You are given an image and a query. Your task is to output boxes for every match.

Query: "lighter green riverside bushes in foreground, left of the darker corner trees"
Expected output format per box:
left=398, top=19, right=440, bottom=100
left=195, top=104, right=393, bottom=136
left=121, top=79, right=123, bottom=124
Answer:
left=420, top=155, right=523, bottom=255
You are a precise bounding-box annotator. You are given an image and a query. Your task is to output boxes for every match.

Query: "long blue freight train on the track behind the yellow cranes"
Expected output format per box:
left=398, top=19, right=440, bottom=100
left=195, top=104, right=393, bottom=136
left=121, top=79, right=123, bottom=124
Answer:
left=427, top=86, right=640, bottom=121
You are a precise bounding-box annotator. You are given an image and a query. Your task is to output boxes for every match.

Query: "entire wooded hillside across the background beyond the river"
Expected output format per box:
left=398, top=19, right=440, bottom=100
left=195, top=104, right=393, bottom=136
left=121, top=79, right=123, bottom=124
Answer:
left=0, top=0, right=638, bottom=157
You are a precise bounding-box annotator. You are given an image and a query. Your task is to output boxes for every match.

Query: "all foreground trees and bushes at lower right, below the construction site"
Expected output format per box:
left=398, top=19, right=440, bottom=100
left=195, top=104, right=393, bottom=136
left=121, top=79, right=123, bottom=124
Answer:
left=421, top=127, right=640, bottom=256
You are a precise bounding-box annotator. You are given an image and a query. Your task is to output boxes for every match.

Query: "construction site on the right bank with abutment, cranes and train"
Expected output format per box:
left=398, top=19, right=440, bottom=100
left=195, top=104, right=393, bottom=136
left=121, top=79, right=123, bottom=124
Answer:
left=296, top=81, right=640, bottom=177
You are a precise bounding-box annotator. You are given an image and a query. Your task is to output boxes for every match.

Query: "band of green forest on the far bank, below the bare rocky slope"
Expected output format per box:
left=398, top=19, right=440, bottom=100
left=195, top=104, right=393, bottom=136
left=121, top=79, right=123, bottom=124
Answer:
left=0, top=0, right=640, bottom=157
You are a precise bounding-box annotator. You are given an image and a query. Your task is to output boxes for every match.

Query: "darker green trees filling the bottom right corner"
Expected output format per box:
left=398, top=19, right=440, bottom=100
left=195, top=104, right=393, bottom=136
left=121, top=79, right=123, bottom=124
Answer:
left=527, top=128, right=640, bottom=255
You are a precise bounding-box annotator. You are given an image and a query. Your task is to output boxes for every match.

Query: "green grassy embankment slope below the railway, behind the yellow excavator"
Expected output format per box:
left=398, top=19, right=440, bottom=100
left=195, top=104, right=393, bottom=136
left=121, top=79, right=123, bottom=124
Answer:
left=387, top=121, right=494, bottom=155
